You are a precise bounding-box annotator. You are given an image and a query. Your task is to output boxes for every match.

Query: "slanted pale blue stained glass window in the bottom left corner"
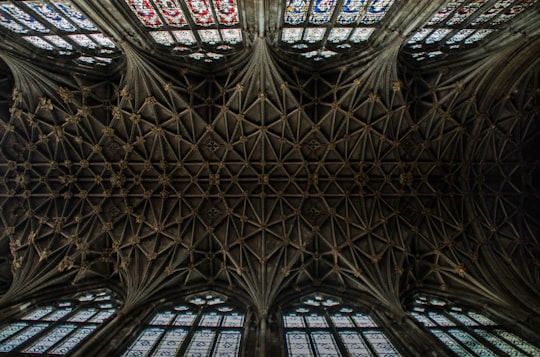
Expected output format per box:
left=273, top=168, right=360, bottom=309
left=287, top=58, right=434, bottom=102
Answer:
left=0, top=290, right=117, bottom=355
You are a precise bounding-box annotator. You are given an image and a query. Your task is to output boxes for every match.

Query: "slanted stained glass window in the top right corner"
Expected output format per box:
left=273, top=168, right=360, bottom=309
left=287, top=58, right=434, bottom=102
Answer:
left=407, top=0, right=537, bottom=61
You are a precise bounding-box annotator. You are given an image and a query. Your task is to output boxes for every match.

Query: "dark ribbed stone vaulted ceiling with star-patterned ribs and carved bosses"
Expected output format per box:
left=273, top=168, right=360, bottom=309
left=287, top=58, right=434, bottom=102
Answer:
left=0, top=0, right=540, bottom=315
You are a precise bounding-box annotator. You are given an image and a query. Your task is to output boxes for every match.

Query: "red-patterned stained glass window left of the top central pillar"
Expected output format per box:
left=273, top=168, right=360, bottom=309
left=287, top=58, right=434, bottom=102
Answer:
left=126, top=0, right=243, bottom=62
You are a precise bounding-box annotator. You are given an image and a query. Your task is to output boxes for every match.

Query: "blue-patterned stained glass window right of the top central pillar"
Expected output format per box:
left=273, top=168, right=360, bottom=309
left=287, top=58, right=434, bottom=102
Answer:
left=280, top=0, right=394, bottom=60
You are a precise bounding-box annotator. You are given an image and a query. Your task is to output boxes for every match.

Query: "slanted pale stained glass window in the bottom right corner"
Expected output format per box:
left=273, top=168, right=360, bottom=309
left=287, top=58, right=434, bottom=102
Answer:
left=411, top=296, right=540, bottom=356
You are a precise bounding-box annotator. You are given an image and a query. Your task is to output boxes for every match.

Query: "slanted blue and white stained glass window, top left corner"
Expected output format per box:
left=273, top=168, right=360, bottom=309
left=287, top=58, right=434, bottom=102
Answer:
left=0, top=0, right=118, bottom=64
